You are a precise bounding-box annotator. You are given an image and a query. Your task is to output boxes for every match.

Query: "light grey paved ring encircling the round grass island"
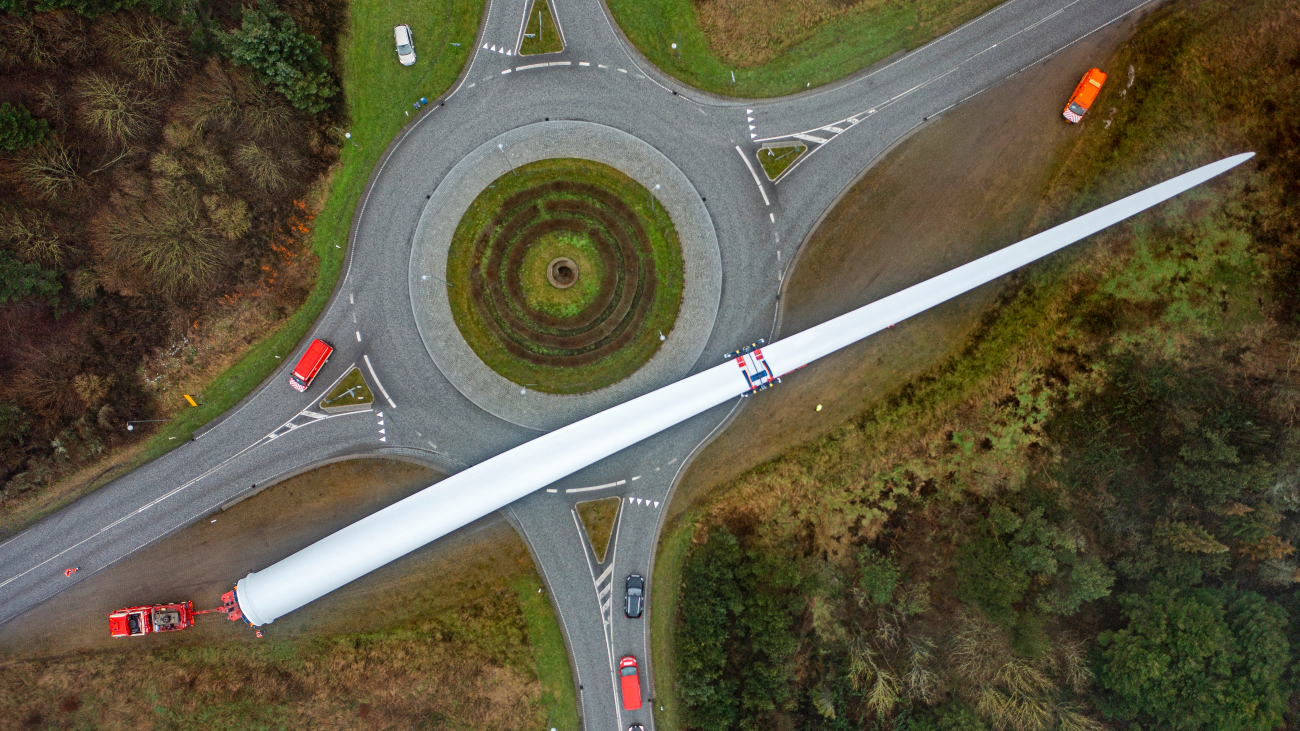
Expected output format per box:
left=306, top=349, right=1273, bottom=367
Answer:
left=410, top=121, right=723, bottom=431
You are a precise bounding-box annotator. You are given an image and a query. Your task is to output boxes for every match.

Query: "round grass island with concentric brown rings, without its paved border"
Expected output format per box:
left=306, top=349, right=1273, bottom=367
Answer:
left=446, top=159, right=684, bottom=394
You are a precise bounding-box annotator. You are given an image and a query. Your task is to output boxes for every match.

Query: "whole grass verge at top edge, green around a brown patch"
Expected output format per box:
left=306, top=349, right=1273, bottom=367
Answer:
left=608, top=0, right=1000, bottom=98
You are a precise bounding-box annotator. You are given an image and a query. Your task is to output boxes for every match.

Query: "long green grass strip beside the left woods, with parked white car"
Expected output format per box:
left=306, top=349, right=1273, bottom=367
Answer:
left=0, top=0, right=484, bottom=533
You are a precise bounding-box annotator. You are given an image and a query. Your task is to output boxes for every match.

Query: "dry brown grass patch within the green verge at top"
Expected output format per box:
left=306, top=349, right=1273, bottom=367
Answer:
left=696, top=0, right=889, bottom=66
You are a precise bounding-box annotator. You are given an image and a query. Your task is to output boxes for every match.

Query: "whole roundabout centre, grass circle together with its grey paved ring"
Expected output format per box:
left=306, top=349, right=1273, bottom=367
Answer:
left=410, top=121, right=722, bottom=431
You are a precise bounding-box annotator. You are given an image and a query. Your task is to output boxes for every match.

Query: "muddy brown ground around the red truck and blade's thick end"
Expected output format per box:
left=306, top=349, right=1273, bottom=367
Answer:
left=0, top=459, right=533, bottom=659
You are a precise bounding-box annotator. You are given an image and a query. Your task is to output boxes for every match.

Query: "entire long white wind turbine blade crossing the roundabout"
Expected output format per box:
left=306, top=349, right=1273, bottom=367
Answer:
left=235, top=152, right=1255, bottom=624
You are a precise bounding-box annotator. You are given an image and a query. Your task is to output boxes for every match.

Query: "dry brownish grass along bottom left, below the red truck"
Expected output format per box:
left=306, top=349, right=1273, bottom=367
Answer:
left=0, top=588, right=541, bottom=731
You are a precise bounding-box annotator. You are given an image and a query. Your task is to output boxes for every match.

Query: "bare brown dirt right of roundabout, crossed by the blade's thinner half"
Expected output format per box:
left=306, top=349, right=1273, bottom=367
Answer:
left=671, top=22, right=1132, bottom=515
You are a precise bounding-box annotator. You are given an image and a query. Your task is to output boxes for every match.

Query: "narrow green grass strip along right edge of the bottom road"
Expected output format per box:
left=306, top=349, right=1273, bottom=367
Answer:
left=649, top=511, right=698, bottom=728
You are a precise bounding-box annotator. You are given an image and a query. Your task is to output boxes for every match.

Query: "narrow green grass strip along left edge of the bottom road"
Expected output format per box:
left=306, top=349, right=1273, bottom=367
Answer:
left=514, top=572, right=580, bottom=731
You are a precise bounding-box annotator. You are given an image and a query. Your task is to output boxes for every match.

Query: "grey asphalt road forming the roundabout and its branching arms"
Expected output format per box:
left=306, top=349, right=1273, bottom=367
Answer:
left=0, top=0, right=1149, bottom=730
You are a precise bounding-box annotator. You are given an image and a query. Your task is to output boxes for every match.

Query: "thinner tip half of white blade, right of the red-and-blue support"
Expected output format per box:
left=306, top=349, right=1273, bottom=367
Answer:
left=763, top=152, right=1255, bottom=375
